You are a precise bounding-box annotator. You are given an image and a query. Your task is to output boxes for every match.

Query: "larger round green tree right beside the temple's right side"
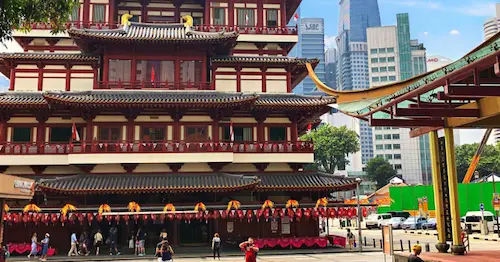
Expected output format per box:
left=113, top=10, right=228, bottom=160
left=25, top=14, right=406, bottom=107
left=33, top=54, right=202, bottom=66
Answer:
left=301, top=124, right=359, bottom=173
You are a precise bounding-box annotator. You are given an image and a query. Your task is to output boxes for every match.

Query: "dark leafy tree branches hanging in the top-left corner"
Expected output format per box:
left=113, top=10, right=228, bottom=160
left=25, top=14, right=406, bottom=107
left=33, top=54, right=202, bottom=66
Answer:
left=0, top=0, right=78, bottom=42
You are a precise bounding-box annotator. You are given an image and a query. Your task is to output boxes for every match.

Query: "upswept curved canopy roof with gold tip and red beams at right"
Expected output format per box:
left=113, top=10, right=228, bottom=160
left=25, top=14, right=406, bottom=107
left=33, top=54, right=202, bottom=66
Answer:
left=309, top=33, right=500, bottom=137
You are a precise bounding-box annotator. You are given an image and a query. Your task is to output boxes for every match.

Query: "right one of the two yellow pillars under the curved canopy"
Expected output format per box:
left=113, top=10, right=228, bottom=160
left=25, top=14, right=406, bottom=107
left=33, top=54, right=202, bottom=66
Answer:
left=444, top=128, right=465, bottom=255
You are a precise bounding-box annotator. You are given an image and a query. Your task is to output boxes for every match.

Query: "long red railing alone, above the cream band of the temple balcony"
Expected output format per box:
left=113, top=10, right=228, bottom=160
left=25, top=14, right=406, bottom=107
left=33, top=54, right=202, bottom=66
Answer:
left=0, top=141, right=314, bottom=155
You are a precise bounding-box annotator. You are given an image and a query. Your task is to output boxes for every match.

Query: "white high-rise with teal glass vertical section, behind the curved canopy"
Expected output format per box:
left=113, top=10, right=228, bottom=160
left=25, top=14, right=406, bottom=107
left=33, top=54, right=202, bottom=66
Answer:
left=367, top=14, right=431, bottom=184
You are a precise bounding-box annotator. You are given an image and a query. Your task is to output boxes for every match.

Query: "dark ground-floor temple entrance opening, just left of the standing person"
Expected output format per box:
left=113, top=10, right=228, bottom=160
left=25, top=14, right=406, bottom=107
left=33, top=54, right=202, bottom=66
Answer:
left=179, top=221, right=209, bottom=246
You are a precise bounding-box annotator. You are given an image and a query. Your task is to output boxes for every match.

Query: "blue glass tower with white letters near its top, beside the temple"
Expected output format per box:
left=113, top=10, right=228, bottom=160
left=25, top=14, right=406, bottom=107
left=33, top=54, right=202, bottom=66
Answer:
left=294, top=18, right=326, bottom=95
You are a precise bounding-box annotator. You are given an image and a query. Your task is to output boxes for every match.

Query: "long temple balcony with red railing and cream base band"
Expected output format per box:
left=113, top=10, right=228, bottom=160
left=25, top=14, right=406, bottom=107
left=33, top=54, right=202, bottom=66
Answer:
left=0, top=141, right=314, bottom=166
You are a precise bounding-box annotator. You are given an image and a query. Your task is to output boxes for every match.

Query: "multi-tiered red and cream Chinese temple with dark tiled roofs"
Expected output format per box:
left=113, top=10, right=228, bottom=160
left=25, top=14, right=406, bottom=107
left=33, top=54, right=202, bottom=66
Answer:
left=0, top=0, right=368, bottom=253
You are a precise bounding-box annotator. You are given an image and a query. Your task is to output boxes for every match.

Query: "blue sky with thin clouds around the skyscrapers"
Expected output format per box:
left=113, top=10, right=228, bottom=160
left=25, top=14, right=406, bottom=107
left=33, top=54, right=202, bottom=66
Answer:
left=300, top=0, right=495, bottom=60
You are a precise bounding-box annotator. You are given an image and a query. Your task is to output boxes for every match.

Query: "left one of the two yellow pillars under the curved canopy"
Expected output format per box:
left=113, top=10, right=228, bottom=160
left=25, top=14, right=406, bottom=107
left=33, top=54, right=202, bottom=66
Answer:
left=429, top=131, right=450, bottom=253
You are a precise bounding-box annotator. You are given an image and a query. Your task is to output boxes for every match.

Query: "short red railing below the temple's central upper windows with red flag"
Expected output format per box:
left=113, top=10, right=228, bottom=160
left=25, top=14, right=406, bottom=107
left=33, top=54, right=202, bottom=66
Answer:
left=97, top=81, right=213, bottom=90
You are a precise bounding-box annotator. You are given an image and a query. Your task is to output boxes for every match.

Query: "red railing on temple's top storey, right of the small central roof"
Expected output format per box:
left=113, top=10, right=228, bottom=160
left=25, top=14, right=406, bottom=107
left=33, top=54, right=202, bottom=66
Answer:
left=194, top=25, right=298, bottom=35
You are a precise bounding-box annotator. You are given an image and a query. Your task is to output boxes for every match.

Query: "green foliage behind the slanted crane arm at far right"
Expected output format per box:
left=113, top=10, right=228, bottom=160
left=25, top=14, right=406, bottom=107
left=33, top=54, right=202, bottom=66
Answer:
left=455, top=143, right=500, bottom=182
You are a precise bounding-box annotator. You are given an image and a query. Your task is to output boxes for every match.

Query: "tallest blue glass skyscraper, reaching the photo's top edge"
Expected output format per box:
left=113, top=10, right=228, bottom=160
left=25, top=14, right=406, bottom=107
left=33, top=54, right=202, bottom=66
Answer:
left=335, top=0, right=380, bottom=165
